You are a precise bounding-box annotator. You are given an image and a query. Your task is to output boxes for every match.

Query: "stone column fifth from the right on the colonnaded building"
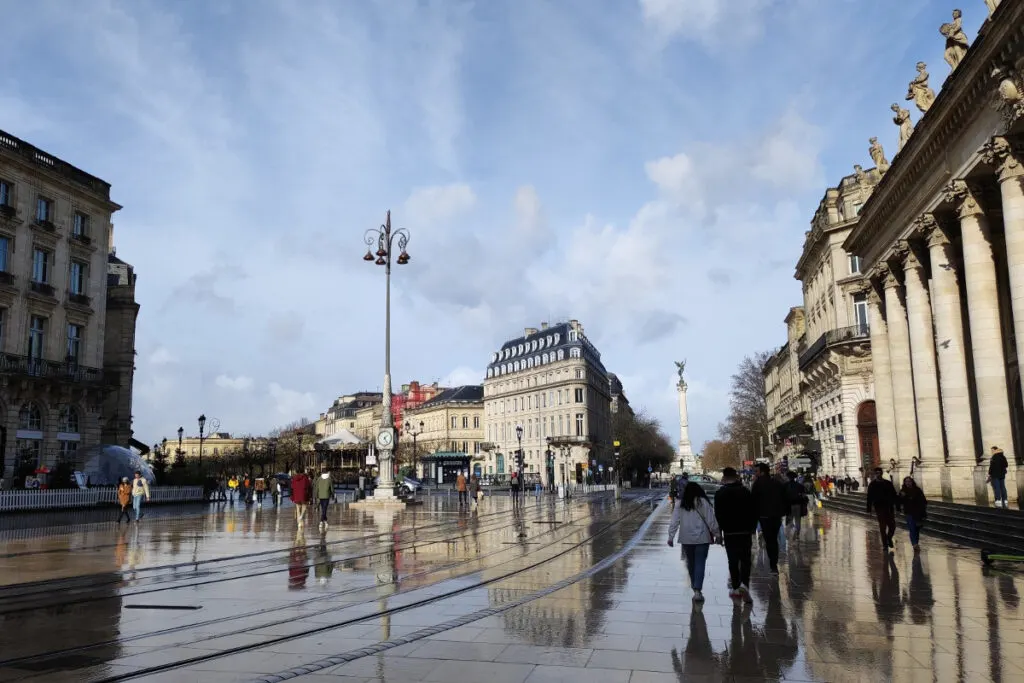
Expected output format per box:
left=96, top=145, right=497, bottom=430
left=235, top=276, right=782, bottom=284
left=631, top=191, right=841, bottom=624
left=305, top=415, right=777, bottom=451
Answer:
left=883, top=271, right=921, bottom=464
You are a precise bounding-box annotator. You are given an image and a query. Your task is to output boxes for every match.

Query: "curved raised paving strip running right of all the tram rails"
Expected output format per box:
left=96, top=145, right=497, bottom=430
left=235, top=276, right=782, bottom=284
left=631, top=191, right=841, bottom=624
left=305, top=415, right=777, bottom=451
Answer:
left=252, top=497, right=665, bottom=683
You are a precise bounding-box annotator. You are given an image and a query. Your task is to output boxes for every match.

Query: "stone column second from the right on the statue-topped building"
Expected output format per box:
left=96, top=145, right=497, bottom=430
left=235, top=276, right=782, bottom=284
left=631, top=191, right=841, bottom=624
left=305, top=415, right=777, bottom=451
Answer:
left=945, top=180, right=1017, bottom=501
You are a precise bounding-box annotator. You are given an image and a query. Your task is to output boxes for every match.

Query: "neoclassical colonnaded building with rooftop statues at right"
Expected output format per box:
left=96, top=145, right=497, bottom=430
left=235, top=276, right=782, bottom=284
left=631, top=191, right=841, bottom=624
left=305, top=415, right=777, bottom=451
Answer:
left=844, top=2, right=1024, bottom=502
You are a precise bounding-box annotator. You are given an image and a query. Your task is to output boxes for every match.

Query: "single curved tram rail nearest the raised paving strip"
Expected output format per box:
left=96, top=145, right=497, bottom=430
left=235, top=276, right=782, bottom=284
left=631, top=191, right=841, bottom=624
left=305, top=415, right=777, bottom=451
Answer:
left=81, top=497, right=654, bottom=683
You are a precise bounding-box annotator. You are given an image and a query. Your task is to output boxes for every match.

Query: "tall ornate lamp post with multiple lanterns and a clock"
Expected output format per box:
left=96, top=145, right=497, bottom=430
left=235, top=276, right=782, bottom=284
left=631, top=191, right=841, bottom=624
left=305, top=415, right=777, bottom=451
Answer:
left=362, top=211, right=410, bottom=500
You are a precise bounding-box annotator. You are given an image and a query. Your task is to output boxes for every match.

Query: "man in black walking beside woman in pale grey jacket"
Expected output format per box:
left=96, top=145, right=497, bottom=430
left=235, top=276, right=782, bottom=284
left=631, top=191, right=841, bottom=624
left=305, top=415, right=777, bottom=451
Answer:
left=715, top=467, right=758, bottom=602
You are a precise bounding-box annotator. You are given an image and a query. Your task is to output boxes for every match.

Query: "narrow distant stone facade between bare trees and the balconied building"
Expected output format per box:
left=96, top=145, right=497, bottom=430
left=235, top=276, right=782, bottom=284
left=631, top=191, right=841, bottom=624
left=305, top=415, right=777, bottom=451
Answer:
left=764, top=306, right=811, bottom=460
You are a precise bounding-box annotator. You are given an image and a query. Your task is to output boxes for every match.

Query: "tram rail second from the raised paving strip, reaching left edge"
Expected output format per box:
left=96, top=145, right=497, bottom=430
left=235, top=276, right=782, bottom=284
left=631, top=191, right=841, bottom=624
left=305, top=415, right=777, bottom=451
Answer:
left=0, top=491, right=606, bottom=668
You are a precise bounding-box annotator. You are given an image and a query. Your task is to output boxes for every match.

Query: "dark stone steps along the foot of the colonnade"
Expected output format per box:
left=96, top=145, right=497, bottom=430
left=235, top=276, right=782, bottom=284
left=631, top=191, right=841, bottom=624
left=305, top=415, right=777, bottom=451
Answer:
left=824, top=495, right=1024, bottom=553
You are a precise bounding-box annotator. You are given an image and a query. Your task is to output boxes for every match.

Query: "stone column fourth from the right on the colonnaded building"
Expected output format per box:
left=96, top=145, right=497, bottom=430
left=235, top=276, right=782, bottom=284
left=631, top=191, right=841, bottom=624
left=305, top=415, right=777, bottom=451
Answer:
left=903, top=247, right=946, bottom=496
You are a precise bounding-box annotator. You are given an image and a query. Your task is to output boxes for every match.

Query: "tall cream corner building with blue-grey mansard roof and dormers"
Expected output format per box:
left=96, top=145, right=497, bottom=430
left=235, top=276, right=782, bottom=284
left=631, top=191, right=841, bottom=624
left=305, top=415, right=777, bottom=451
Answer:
left=483, top=321, right=611, bottom=485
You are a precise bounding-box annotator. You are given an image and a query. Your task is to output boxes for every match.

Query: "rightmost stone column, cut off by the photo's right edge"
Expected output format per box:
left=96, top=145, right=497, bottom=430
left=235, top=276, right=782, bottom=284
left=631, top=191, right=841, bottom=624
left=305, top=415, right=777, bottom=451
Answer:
left=982, top=137, right=1024, bottom=500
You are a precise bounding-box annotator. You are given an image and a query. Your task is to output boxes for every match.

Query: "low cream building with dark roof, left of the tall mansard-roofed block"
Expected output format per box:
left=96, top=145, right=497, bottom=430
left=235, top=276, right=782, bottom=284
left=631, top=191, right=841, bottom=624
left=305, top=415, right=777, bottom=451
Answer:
left=399, top=384, right=484, bottom=482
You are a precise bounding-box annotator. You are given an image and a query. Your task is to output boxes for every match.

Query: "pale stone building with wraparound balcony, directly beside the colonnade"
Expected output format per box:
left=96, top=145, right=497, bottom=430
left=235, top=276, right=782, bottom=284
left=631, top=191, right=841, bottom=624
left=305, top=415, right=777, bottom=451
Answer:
left=795, top=166, right=881, bottom=478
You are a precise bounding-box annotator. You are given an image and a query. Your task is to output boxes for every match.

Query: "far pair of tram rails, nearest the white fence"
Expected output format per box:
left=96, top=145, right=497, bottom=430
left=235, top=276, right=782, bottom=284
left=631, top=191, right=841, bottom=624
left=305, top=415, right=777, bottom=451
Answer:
left=0, top=499, right=536, bottom=616
